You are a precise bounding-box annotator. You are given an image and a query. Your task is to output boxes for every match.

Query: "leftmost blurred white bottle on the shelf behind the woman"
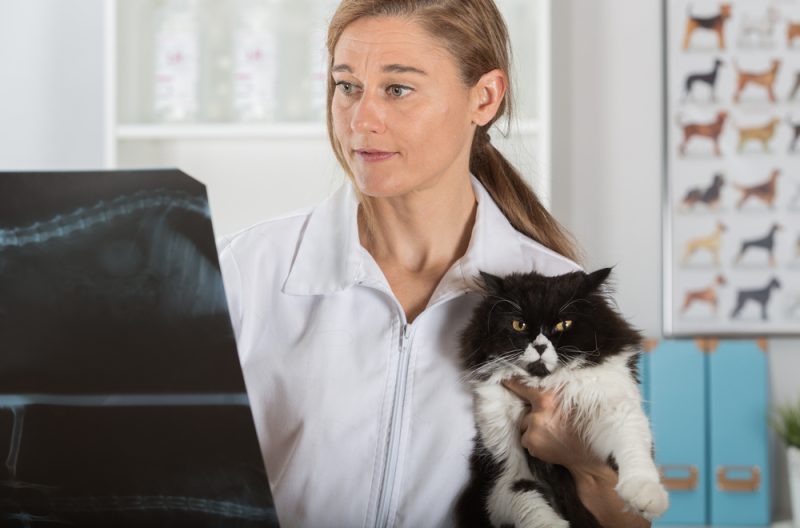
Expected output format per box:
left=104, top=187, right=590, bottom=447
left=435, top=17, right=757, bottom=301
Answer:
left=153, top=0, right=200, bottom=122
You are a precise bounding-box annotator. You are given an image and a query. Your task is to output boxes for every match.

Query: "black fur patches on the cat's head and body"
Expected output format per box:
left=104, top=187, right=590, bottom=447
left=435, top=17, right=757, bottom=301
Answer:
left=456, top=268, right=642, bottom=528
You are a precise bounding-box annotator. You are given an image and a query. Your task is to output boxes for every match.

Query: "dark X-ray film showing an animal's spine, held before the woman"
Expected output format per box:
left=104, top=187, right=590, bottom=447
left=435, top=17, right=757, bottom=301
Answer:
left=0, top=170, right=277, bottom=528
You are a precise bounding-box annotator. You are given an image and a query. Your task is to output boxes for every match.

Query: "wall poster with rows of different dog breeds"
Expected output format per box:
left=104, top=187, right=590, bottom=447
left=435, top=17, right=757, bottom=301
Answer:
left=664, top=0, right=800, bottom=336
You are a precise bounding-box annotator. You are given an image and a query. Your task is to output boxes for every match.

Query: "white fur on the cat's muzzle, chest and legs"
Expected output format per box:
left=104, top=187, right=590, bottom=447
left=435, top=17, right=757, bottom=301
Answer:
left=474, top=334, right=669, bottom=528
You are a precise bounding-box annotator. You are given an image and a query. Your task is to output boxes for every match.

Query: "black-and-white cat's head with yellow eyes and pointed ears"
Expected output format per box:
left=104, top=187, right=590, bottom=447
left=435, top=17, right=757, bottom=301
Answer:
left=461, top=268, right=642, bottom=382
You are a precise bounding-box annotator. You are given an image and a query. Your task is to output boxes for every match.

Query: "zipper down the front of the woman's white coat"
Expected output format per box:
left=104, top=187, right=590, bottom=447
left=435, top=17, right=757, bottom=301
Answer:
left=375, top=323, right=411, bottom=528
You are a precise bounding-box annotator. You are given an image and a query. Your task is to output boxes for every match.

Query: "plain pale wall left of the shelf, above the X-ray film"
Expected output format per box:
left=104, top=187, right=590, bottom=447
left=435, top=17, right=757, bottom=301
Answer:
left=0, top=0, right=103, bottom=170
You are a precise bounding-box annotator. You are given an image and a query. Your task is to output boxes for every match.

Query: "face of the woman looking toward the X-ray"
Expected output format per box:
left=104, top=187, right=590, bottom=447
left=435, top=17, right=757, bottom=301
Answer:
left=332, top=17, right=477, bottom=197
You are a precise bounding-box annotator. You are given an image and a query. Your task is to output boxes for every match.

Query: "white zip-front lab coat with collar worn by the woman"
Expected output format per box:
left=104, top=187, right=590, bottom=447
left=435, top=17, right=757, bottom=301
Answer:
left=219, top=177, right=580, bottom=528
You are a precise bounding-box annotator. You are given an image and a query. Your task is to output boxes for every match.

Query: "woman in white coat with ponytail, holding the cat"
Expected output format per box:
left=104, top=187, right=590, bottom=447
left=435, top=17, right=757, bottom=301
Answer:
left=220, top=0, right=649, bottom=528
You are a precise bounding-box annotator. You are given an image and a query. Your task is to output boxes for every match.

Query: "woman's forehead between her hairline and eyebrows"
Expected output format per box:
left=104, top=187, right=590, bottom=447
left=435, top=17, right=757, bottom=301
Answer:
left=333, top=17, right=450, bottom=73
